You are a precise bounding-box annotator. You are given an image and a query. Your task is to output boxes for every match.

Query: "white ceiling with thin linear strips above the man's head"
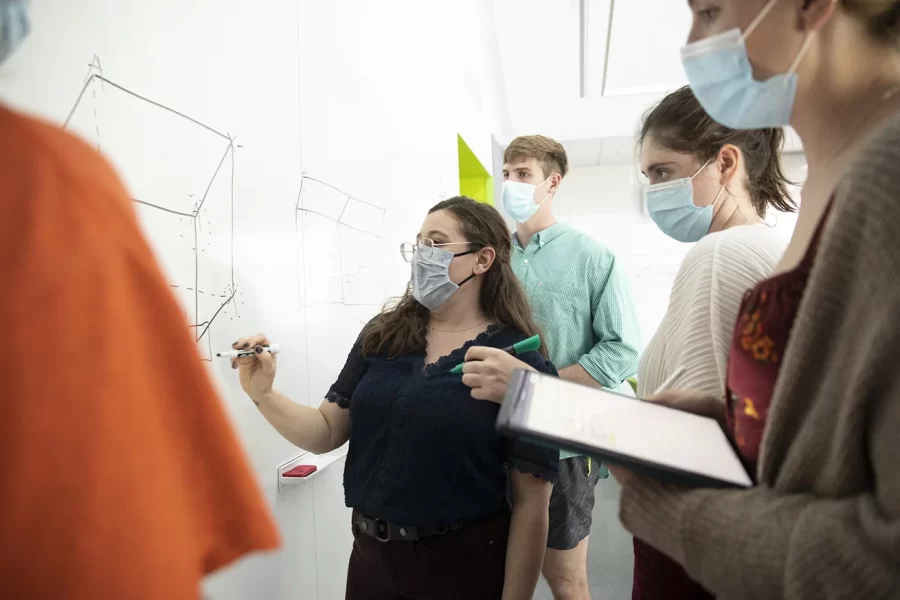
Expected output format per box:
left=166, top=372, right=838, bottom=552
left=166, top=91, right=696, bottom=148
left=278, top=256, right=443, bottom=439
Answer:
left=492, top=0, right=800, bottom=166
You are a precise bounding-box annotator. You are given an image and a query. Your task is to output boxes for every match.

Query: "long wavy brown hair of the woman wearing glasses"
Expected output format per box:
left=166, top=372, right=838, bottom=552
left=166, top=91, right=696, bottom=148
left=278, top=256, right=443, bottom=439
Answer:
left=362, top=196, right=547, bottom=358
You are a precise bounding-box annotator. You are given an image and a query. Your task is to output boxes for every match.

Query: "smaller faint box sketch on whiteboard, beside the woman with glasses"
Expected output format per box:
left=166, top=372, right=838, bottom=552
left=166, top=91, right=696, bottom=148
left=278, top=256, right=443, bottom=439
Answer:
left=295, top=173, right=387, bottom=308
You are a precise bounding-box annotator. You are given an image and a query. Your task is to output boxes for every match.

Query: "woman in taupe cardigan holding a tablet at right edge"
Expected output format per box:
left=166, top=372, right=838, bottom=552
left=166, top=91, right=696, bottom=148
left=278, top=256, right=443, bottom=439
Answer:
left=610, top=0, right=900, bottom=600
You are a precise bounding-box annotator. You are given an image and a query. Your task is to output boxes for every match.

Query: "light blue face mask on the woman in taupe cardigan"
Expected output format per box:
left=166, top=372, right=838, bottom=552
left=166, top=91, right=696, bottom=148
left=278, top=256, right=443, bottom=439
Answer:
left=681, top=0, right=812, bottom=129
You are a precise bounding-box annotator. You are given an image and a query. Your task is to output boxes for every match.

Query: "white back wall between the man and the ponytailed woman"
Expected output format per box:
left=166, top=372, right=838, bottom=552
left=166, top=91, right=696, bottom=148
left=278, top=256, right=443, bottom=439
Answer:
left=554, top=155, right=805, bottom=344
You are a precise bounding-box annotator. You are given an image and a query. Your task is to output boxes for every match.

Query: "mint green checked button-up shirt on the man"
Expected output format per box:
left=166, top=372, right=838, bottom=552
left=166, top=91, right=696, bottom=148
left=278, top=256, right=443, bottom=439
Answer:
left=512, top=223, right=640, bottom=458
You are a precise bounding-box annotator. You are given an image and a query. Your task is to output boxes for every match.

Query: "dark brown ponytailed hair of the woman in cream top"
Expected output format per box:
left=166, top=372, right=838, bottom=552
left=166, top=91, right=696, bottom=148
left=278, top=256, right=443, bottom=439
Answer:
left=638, top=86, right=797, bottom=217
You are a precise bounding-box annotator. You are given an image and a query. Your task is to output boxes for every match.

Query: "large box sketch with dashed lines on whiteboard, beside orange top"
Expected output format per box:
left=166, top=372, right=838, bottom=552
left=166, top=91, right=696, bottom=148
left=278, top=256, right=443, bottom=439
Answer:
left=63, top=56, right=242, bottom=361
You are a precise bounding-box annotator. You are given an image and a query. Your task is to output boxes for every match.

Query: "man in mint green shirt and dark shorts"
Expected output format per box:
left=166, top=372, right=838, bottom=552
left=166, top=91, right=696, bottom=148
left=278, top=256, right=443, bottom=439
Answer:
left=501, top=136, right=640, bottom=600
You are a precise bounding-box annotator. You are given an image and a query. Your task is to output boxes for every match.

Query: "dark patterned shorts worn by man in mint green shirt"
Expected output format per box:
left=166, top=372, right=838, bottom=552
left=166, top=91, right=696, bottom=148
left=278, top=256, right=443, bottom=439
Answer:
left=547, top=456, right=606, bottom=550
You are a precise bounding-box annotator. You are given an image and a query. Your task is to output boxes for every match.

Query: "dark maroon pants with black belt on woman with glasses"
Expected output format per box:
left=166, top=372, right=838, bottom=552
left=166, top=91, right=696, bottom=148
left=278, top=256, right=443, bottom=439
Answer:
left=346, top=513, right=509, bottom=600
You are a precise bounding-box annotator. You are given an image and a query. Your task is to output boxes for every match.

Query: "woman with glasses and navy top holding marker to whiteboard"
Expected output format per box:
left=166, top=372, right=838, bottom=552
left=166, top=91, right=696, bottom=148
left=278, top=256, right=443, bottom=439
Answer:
left=235, top=198, right=558, bottom=600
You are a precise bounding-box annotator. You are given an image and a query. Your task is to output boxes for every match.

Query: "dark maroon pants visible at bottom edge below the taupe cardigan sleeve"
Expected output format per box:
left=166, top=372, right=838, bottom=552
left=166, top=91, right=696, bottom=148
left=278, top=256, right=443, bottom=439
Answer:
left=631, top=538, right=715, bottom=600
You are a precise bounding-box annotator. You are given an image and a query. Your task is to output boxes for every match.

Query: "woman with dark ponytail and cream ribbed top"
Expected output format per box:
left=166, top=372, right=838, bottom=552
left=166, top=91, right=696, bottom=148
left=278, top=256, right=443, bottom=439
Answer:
left=632, top=87, right=794, bottom=600
